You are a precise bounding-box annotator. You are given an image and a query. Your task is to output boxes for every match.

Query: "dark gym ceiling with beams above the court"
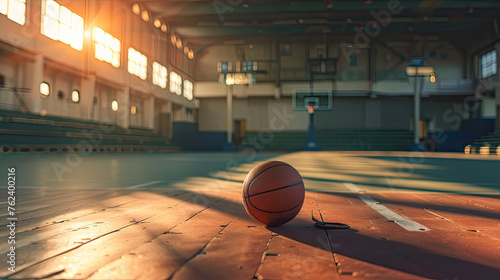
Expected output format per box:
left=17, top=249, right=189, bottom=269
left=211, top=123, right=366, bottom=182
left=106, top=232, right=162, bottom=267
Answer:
left=131, top=0, right=500, bottom=49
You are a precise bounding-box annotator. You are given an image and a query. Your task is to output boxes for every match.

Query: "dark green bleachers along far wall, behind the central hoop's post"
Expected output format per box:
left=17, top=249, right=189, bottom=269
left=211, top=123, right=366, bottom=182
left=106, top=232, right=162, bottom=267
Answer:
left=241, top=129, right=413, bottom=151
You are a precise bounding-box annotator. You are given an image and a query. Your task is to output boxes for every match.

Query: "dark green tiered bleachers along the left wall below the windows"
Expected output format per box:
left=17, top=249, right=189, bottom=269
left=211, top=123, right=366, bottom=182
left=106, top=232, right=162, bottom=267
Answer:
left=0, top=110, right=179, bottom=153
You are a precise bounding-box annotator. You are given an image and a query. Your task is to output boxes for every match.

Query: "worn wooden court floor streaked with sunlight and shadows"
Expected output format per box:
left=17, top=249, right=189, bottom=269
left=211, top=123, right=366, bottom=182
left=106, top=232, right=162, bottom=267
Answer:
left=0, top=152, right=500, bottom=280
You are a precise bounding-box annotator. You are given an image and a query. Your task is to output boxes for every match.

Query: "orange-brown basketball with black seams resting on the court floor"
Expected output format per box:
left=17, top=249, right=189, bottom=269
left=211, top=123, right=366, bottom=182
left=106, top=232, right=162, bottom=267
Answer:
left=243, top=161, right=305, bottom=226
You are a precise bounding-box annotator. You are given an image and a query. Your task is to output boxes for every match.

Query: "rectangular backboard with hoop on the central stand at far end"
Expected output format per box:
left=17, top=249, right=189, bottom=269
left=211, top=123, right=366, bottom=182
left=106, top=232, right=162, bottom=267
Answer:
left=292, top=89, right=333, bottom=111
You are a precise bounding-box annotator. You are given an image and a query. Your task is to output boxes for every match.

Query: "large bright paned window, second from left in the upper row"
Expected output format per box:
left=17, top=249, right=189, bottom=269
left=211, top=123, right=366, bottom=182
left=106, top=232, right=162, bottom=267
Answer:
left=40, top=0, right=83, bottom=51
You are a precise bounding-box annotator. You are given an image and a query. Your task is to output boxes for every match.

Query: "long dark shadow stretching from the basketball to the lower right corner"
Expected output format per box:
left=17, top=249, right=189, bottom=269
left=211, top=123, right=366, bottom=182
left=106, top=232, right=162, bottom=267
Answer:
left=266, top=213, right=500, bottom=280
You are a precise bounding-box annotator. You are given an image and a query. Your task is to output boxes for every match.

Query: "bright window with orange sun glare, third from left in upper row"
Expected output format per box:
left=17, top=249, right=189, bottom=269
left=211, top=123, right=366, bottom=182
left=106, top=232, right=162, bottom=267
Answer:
left=94, top=27, right=120, bottom=68
